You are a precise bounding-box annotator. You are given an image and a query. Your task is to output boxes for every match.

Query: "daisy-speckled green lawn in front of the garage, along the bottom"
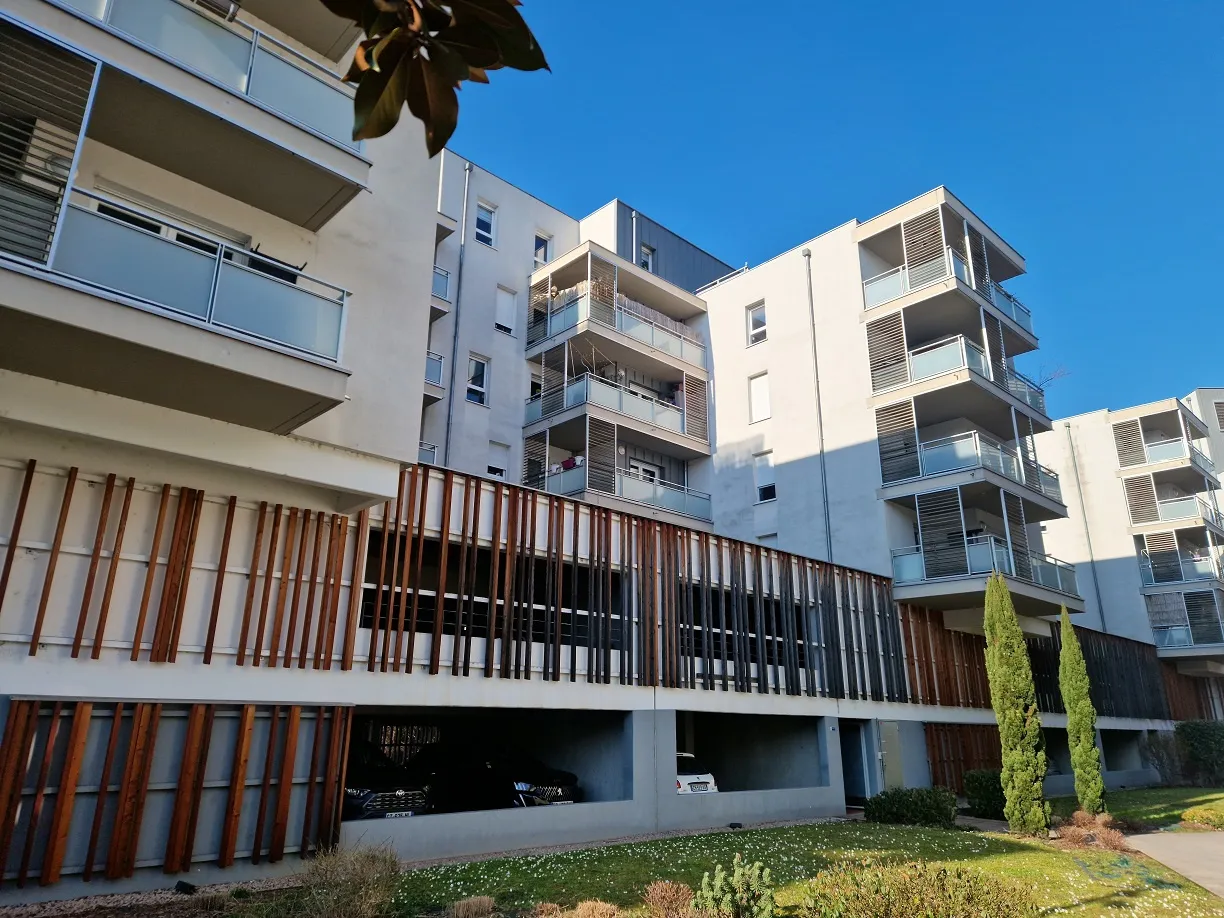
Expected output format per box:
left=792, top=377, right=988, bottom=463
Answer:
left=395, top=823, right=1224, bottom=918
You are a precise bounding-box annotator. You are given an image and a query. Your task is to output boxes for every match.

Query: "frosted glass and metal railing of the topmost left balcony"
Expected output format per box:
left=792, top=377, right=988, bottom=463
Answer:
left=62, top=0, right=361, bottom=151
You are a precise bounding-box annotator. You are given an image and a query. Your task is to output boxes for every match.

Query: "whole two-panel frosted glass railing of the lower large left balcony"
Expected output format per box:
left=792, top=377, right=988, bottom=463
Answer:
left=50, top=191, right=348, bottom=361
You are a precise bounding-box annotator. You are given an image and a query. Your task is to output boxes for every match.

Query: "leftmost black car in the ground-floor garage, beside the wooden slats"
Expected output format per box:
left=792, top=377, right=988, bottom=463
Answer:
left=341, top=737, right=437, bottom=819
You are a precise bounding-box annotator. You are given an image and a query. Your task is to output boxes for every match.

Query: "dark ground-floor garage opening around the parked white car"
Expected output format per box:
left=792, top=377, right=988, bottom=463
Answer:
left=676, top=711, right=829, bottom=792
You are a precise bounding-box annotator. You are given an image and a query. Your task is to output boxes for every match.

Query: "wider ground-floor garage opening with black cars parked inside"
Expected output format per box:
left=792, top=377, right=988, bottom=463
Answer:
left=344, top=707, right=633, bottom=820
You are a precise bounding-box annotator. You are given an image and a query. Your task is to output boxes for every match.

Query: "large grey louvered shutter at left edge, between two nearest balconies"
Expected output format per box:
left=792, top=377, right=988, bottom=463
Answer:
left=0, top=20, right=97, bottom=264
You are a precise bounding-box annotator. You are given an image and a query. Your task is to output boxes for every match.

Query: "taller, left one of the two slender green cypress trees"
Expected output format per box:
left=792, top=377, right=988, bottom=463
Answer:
left=984, top=574, right=1050, bottom=835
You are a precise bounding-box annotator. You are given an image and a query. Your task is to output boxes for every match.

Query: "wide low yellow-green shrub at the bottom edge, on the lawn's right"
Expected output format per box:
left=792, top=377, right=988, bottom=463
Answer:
left=798, top=862, right=1037, bottom=918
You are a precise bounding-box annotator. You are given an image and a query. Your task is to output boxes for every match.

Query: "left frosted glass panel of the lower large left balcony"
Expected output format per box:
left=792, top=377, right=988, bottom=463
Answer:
left=51, top=207, right=217, bottom=318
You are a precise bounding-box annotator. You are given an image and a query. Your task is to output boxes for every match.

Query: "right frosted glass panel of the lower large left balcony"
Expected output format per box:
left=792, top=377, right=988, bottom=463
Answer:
left=213, top=262, right=344, bottom=360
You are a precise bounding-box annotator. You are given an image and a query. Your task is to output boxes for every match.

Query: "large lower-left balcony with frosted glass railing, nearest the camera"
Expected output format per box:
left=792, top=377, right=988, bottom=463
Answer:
left=0, top=191, right=349, bottom=432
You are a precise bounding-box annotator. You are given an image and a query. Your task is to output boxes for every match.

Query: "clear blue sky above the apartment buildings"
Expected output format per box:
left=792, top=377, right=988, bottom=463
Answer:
left=452, top=0, right=1224, bottom=415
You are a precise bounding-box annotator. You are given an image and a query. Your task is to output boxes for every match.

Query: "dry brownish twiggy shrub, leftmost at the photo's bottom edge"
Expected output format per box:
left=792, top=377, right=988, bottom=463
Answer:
left=295, top=847, right=399, bottom=918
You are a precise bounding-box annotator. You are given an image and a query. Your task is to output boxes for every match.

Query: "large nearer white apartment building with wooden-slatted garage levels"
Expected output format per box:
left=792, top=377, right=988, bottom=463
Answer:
left=0, top=0, right=1218, bottom=905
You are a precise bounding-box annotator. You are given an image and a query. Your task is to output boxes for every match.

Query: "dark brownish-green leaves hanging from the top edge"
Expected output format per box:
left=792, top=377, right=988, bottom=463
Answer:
left=321, top=0, right=548, bottom=157
